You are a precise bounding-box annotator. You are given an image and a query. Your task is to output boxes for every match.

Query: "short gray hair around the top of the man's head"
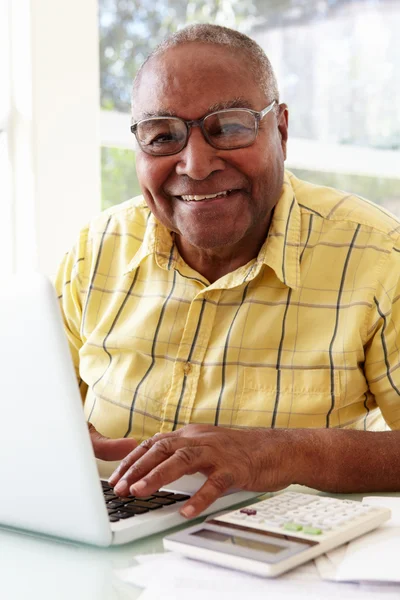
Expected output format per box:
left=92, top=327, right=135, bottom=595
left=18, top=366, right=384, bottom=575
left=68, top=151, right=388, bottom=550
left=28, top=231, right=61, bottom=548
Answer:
left=132, top=23, right=279, bottom=110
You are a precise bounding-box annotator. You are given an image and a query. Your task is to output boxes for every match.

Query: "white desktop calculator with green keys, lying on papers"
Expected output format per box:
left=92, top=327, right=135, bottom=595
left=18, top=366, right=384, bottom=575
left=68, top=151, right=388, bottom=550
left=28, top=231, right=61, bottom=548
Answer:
left=164, top=492, right=391, bottom=577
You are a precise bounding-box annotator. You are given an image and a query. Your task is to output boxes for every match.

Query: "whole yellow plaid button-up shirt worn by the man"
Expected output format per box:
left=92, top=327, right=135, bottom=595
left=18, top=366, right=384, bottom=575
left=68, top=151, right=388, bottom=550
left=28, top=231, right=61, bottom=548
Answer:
left=56, top=172, right=400, bottom=441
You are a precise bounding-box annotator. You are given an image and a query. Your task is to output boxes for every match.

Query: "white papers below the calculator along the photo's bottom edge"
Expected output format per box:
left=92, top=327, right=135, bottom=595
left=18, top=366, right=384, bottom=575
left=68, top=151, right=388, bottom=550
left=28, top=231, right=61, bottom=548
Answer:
left=117, top=552, right=399, bottom=600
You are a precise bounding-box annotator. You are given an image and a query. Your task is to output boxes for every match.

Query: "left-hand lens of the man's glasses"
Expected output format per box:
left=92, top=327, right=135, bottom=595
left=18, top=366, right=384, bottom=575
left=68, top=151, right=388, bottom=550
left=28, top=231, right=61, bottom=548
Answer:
left=136, top=117, right=187, bottom=155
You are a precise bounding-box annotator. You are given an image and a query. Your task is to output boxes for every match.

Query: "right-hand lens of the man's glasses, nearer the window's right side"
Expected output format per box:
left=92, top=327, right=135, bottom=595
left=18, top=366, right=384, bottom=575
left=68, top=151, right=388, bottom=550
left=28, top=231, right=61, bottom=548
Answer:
left=204, top=110, right=256, bottom=149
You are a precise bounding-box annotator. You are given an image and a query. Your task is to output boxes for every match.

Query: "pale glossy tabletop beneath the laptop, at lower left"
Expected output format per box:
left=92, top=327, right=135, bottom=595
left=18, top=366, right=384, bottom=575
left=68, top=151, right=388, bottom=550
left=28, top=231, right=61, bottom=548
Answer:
left=0, top=486, right=400, bottom=600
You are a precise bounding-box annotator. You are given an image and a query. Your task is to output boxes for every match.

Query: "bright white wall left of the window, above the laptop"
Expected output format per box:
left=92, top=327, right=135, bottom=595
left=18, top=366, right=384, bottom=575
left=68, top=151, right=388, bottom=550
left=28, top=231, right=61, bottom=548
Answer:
left=8, top=0, right=100, bottom=276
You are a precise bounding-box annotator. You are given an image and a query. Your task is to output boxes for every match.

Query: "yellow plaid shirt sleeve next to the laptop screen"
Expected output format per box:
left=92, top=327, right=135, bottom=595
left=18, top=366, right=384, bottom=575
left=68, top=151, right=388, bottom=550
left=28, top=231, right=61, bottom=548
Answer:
left=54, top=230, right=90, bottom=401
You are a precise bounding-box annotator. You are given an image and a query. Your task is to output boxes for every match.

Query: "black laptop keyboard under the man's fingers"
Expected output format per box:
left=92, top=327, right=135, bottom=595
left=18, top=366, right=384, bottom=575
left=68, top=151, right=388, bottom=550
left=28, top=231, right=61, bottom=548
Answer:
left=101, top=481, right=190, bottom=523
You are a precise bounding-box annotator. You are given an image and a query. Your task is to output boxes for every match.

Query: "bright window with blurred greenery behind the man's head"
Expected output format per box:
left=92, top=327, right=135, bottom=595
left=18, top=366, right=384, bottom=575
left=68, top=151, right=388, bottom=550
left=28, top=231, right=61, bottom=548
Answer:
left=99, top=0, right=400, bottom=216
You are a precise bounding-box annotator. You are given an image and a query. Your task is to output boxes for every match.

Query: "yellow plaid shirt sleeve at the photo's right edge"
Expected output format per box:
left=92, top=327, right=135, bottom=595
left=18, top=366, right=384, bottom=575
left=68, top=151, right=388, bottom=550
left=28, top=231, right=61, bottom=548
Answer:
left=364, top=241, right=400, bottom=429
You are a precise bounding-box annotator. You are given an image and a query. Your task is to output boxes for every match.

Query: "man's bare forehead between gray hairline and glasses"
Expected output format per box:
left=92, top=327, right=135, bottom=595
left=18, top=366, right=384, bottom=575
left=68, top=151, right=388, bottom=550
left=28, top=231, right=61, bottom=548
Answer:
left=132, top=44, right=264, bottom=120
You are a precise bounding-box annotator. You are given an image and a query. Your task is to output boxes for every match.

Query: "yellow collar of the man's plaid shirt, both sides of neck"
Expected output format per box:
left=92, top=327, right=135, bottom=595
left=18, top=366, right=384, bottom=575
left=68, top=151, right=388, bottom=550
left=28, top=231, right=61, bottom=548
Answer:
left=126, top=172, right=301, bottom=289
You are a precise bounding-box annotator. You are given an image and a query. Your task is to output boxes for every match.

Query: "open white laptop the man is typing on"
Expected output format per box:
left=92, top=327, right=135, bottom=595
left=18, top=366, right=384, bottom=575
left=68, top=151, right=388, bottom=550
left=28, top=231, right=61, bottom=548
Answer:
left=0, top=273, right=259, bottom=546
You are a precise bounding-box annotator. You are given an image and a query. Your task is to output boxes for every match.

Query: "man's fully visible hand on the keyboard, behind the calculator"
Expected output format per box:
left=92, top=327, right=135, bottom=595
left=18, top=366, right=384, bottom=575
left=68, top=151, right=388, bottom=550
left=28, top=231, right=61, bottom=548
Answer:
left=109, top=425, right=296, bottom=517
